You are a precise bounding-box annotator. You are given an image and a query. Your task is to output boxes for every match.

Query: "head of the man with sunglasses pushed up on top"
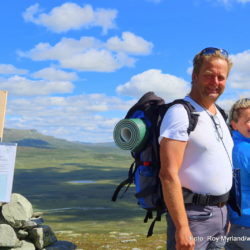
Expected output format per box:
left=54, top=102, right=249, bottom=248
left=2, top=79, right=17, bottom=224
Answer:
left=190, top=47, right=232, bottom=108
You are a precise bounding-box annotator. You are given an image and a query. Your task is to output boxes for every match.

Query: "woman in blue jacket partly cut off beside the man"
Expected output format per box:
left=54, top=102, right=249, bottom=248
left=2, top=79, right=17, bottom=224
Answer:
left=226, top=98, right=250, bottom=250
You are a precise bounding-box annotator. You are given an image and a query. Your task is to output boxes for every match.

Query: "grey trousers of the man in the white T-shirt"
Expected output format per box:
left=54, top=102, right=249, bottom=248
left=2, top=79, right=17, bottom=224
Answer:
left=167, top=205, right=228, bottom=250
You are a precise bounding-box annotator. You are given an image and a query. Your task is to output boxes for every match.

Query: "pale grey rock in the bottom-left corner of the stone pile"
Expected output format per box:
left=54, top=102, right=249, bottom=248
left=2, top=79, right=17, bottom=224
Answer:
left=0, top=224, right=21, bottom=248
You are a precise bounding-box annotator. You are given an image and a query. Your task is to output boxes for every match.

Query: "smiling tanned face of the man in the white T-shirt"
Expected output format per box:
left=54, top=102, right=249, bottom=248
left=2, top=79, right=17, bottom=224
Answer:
left=192, top=58, right=228, bottom=102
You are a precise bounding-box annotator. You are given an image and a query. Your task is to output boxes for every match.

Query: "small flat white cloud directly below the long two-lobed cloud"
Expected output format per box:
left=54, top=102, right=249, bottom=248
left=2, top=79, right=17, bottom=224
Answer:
left=32, top=68, right=78, bottom=81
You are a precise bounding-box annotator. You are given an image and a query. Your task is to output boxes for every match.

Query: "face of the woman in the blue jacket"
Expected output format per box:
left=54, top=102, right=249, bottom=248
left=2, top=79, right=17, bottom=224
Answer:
left=231, top=108, right=250, bottom=138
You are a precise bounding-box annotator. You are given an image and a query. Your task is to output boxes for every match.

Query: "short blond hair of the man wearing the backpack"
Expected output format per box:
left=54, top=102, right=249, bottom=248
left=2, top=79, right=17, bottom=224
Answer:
left=193, top=50, right=233, bottom=76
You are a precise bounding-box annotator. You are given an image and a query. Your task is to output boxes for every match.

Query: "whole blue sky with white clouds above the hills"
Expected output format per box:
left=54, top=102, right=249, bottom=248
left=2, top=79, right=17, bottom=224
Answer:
left=0, top=0, right=250, bottom=142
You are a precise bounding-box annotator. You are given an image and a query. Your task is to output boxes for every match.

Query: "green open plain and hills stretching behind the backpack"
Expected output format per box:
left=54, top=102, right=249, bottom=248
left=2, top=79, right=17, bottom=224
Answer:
left=4, top=129, right=166, bottom=249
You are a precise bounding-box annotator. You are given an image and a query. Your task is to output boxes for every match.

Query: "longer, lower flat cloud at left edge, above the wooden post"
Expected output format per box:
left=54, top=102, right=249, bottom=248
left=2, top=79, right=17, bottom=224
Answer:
left=0, top=75, right=74, bottom=96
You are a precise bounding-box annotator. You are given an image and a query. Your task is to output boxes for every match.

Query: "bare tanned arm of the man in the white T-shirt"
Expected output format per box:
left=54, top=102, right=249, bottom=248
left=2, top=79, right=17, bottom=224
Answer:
left=160, top=138, right=195, bottom=250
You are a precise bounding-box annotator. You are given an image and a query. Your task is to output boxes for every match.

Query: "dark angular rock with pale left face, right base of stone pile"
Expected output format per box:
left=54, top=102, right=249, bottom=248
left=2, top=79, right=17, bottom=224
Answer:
left=30, top=225, right=57, bottom=249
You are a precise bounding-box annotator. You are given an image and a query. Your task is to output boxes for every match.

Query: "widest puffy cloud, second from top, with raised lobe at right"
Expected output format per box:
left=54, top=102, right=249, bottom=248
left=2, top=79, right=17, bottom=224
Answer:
left=18, top=32, right=153, bottom=72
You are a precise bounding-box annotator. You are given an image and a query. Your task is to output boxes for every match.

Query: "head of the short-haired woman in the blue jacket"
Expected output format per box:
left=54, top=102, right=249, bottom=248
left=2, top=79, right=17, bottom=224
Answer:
left=229, top=98, right=250, bottom=138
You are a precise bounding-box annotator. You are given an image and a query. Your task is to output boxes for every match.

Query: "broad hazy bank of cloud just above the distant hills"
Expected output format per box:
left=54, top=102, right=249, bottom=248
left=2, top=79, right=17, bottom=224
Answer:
left=6, top=94, right=134, bottom=142
